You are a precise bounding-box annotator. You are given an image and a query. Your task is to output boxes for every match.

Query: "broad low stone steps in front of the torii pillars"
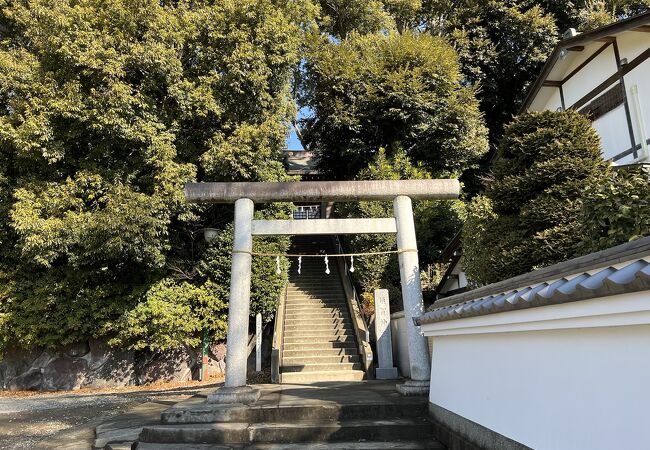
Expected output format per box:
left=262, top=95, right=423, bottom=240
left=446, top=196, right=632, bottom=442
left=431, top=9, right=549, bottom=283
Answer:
left=132, top=381, right=445, bottom=450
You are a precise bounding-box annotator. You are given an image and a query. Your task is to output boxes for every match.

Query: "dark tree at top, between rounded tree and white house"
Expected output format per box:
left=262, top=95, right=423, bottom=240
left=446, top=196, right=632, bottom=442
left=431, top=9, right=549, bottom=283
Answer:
left=443, top=0, right=558, bottom=139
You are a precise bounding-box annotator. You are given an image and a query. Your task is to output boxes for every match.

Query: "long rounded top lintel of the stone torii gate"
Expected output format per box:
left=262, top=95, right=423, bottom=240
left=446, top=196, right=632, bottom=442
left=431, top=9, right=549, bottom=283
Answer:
left=185, top=179, right=460, bottom=203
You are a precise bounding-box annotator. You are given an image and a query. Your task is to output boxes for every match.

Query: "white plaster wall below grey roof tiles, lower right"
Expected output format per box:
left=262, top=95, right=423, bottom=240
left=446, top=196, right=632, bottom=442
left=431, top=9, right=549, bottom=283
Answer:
left=424, top=292, right=650, bottom=450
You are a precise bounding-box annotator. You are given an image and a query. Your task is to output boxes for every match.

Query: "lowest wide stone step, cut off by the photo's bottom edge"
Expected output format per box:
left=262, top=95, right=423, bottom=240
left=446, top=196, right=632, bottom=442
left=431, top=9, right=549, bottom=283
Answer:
left=135, top=440, right=445, bottom=450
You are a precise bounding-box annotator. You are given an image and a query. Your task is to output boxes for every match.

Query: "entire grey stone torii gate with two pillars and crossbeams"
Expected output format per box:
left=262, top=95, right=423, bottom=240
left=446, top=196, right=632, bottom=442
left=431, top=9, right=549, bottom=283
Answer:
left=185, top=180, right=460, bottom=403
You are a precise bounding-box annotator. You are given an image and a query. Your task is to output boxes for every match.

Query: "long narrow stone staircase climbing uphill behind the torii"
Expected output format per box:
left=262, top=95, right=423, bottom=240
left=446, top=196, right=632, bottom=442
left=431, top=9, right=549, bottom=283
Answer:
left=280, top=236, right=365, bottom=384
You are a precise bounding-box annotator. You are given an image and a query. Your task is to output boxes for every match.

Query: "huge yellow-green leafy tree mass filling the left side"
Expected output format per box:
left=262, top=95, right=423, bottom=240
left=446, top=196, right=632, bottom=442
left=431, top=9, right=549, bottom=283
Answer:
left=0, top=0, right=306, bottom=349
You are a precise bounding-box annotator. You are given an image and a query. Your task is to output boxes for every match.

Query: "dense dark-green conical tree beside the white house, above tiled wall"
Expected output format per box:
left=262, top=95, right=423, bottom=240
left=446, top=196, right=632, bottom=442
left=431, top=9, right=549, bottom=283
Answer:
left=463, top=111, right=607, bottom=284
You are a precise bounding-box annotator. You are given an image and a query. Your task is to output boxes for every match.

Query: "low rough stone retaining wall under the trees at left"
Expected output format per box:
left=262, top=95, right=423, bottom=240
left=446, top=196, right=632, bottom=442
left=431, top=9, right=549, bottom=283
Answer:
left=0, top=340, right=226, bottom=391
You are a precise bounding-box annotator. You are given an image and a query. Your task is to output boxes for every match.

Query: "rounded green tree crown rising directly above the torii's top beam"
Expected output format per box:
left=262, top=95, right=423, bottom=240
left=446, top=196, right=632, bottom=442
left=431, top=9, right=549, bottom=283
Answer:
left=302, top=32, right=487, bottom=179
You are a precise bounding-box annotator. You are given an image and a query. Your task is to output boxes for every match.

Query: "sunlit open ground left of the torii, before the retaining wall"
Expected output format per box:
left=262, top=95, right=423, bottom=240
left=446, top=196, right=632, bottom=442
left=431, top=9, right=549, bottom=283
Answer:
left=0, top=384, right=223, bottom=450
